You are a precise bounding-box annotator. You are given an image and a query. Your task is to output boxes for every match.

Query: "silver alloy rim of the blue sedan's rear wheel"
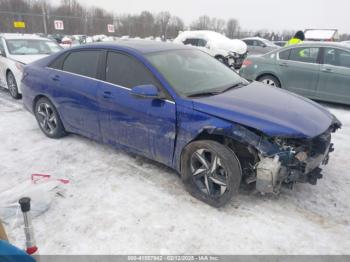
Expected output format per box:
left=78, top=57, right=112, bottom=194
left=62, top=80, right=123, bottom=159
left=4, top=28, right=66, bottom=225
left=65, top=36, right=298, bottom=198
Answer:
left=37, top=103, right=57, bottom=134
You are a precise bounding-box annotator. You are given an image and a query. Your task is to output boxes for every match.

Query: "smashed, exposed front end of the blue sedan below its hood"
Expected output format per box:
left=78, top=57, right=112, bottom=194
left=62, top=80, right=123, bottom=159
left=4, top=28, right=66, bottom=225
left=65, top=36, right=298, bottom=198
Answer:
left=216, top=115, right=341, bottom=194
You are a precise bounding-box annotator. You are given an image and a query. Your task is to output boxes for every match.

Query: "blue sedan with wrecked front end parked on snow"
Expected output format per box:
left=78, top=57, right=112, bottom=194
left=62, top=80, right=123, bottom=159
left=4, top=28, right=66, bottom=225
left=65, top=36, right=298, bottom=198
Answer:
left=22, top=41, right=341, bottom=207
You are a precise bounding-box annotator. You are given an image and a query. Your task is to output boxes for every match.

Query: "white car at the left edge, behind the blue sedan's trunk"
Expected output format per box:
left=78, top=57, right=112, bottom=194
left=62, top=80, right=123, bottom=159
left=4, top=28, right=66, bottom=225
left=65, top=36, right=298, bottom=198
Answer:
left=0, top=34, right=62, bottom=99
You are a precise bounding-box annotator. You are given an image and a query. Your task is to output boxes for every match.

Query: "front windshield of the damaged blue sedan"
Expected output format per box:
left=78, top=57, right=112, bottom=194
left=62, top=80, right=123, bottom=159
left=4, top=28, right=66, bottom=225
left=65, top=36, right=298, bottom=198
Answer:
left=147, top=49, right=244, bottom=96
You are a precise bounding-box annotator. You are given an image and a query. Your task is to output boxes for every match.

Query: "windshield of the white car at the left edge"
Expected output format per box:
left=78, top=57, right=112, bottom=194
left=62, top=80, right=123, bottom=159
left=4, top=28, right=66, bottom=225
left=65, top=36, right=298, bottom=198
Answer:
left=6, top=39, right=62, bottom=55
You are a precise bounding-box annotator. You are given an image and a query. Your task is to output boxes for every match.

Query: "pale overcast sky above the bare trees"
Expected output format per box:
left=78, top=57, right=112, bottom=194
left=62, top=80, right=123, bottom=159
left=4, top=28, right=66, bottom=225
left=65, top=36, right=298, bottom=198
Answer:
left=62, top=0, right=350, bottom=33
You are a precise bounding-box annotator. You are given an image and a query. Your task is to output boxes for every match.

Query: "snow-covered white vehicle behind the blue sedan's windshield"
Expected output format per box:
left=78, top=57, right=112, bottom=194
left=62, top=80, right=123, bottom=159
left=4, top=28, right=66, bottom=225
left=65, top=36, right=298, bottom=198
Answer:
left=174, top=30, right=247, bottom=69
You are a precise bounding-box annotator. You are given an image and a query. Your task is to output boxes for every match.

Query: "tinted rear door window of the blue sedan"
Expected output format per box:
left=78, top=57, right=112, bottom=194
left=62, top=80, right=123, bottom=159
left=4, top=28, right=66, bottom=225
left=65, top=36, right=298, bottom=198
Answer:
left=62, top=50, right=100, bottom=78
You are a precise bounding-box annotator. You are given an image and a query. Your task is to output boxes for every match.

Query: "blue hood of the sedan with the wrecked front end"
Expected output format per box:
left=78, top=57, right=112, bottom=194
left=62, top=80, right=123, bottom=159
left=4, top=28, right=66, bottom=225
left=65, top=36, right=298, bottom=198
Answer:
left=193, top=82, right=335, bottom=138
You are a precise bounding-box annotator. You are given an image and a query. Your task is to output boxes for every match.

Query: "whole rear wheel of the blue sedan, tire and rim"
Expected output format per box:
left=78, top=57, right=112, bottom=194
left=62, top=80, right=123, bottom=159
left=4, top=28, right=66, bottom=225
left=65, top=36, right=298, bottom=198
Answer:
left=34, top=97, right=67, bottom=138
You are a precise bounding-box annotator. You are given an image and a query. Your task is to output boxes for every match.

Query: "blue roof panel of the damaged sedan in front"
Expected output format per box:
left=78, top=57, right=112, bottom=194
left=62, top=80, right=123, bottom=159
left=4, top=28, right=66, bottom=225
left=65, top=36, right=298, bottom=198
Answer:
left=72, top=39, right=195, bottom=54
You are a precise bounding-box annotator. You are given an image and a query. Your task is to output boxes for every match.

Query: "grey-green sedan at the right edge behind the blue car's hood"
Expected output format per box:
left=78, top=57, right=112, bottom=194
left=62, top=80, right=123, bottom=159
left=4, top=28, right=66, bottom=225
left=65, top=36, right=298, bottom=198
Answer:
left=240, top=42, right=350, bottom=105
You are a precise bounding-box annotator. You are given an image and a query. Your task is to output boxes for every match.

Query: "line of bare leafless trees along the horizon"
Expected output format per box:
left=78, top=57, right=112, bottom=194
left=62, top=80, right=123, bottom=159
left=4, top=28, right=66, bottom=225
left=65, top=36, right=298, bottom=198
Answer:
left=0, top=0, right=350, bottom=40
